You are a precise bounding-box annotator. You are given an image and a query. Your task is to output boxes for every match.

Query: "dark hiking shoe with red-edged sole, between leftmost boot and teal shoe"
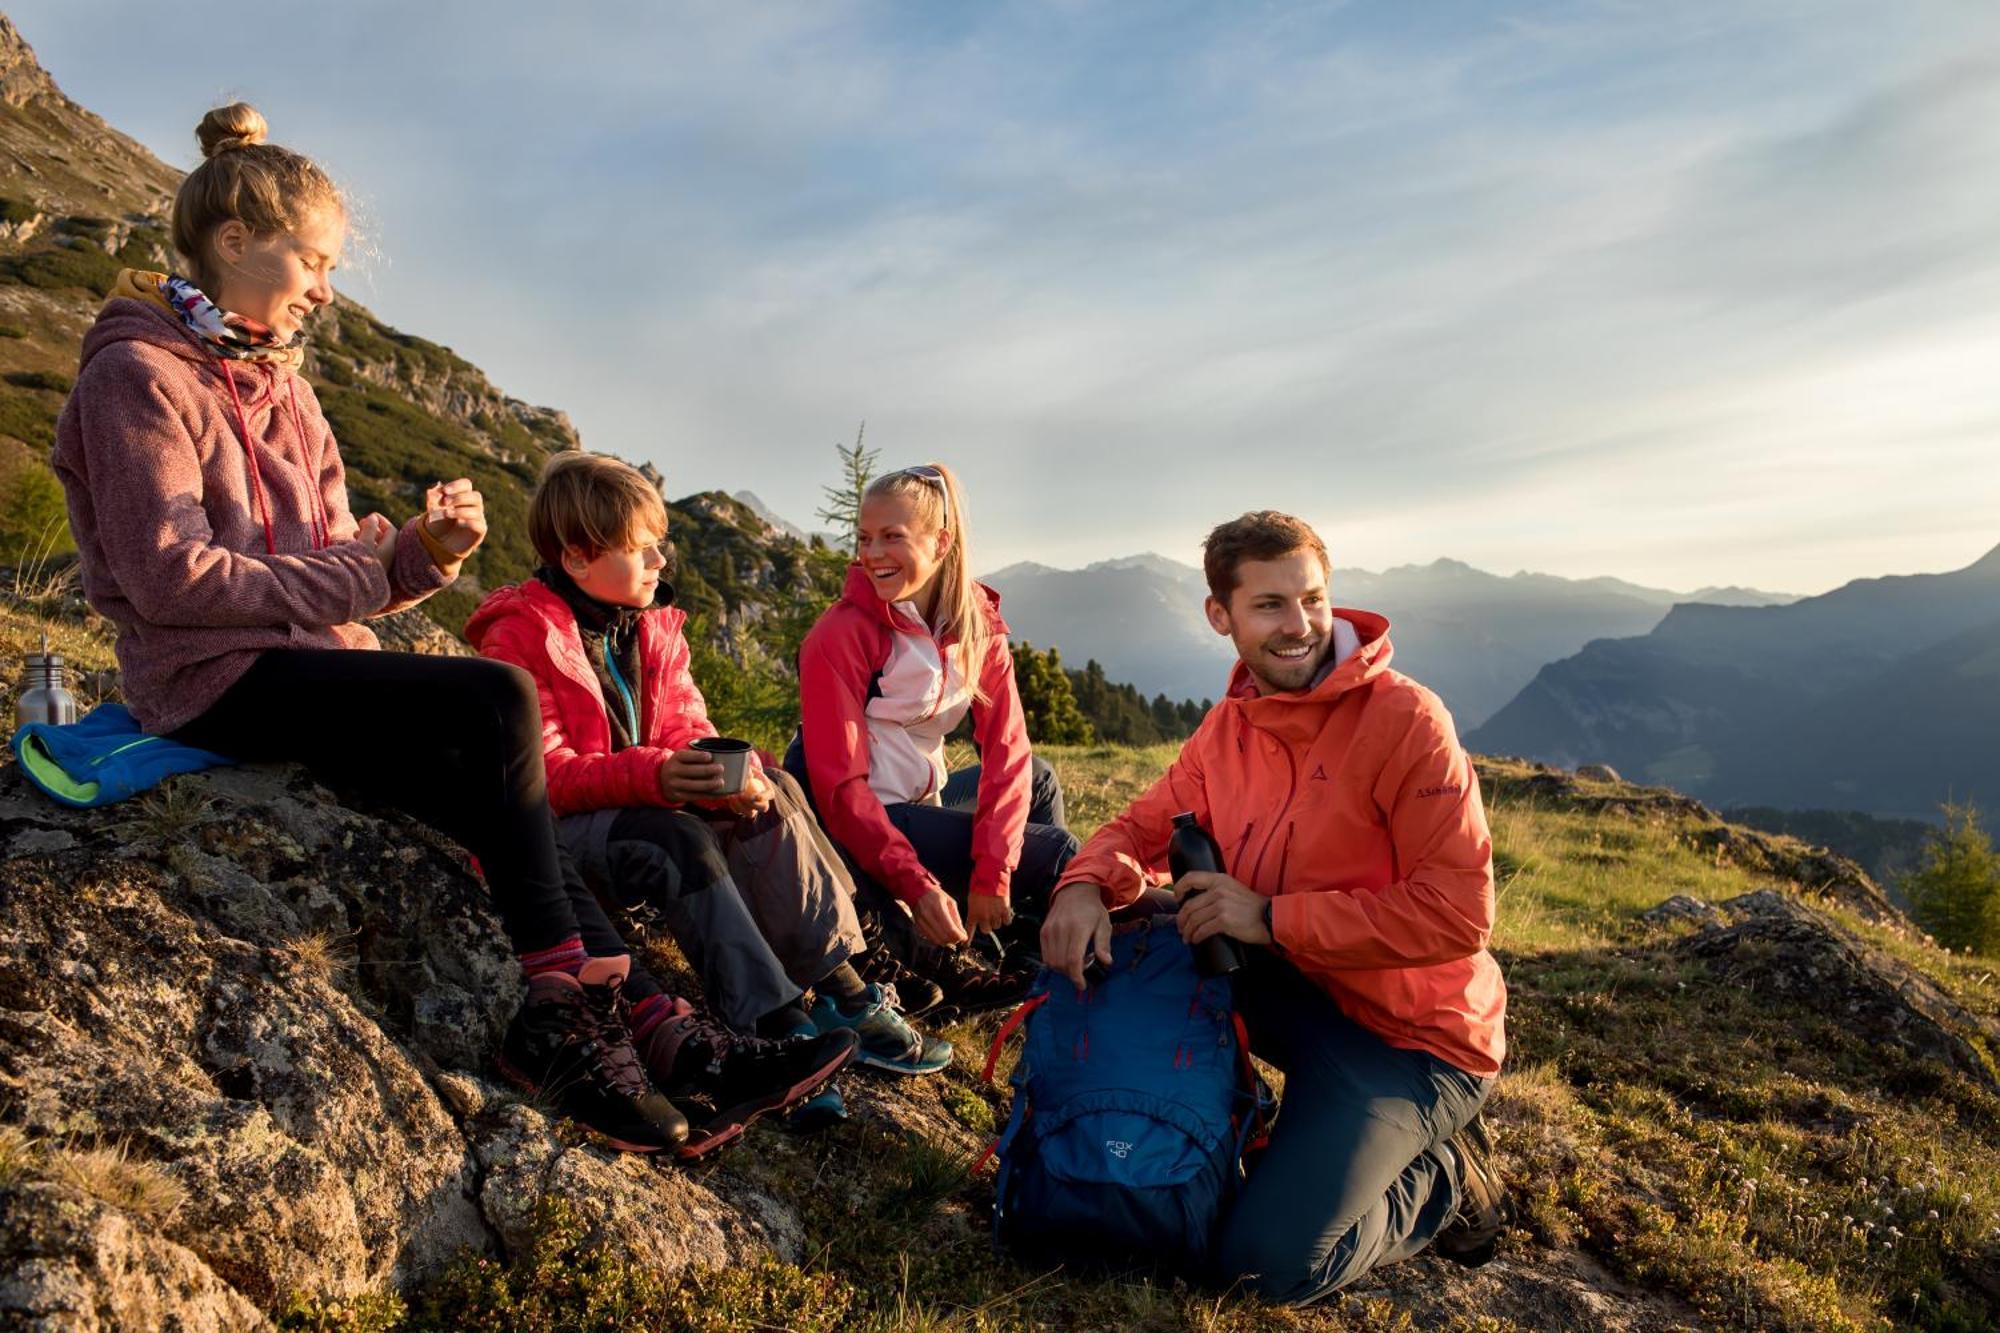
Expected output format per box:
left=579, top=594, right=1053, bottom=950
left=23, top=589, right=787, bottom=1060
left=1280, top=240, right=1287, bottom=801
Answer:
left=638, top=1001, right=856, bottom=1159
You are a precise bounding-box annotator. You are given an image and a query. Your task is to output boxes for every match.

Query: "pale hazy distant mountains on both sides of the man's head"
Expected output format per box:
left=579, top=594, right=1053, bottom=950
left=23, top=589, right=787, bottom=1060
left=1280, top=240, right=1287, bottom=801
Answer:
left=984, top=552, right=1792, bottom=729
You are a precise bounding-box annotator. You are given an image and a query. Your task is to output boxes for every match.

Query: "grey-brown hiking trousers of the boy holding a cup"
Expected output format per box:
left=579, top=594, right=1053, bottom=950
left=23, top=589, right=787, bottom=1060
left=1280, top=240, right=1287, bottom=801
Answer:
left=556, top=773, right=864, bottom=1033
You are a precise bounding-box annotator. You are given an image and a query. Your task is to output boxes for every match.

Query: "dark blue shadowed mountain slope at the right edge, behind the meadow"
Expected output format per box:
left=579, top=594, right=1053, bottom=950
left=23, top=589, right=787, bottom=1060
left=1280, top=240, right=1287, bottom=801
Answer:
left=1466, top=546, right=2000, bottom=819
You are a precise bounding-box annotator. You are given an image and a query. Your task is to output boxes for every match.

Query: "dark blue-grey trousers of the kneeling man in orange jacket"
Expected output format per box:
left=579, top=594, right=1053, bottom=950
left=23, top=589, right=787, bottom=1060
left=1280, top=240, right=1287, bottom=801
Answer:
left=1216, top=949, right=1492, bottom=1305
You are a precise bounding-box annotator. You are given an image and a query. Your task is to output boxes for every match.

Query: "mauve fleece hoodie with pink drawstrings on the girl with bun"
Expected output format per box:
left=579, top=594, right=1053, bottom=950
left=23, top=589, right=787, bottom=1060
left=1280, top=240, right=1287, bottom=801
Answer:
left=50, top=298, right=458, bottom=735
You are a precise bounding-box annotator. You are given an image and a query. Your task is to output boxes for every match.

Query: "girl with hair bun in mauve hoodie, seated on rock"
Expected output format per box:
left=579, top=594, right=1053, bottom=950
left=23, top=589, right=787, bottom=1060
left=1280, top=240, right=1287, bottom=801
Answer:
left=52, top=104, right=712, bottom=1151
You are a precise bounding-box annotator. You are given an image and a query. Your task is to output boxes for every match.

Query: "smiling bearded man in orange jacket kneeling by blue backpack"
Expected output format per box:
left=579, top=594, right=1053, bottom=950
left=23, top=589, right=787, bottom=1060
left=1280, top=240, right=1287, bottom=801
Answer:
left=1042, top=510, right=1506, bottom=1305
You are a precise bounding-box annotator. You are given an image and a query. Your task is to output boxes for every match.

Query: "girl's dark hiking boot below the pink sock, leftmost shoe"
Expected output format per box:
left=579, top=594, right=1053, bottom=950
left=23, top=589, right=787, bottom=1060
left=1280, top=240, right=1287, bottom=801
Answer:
left=500, top=957, right=688, bottom=1153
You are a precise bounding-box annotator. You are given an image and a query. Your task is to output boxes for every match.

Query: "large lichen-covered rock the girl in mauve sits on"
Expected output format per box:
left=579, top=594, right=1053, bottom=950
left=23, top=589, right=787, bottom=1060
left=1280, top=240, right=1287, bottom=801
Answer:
left=0, top=767, right=802, bottom=1327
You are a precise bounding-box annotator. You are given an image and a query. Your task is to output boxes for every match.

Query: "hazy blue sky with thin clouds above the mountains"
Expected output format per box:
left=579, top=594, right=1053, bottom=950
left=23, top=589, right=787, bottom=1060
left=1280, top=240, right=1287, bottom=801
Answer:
left=0, top=0, right=2000, bottom=592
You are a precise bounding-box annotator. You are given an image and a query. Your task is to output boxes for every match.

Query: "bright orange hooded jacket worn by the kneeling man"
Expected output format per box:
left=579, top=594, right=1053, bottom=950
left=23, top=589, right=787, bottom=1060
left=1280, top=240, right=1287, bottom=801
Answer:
left=1058, top=610, right=1506, bottom=1077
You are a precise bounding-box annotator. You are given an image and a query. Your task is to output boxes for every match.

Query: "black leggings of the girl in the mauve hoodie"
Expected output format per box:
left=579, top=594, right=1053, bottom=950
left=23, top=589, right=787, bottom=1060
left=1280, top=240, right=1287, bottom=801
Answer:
left=174, top=648, right=584, bottom=953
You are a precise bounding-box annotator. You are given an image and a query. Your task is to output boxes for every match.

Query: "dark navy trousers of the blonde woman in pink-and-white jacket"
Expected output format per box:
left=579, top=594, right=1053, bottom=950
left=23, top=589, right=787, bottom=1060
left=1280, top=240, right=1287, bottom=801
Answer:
left=784, top=737, right=1078, bottom=944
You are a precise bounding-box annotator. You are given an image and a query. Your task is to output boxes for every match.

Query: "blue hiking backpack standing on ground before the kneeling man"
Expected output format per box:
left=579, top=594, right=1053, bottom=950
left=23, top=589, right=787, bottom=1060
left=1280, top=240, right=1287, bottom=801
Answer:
left=986, top=919, right=1260, bottom=1273
